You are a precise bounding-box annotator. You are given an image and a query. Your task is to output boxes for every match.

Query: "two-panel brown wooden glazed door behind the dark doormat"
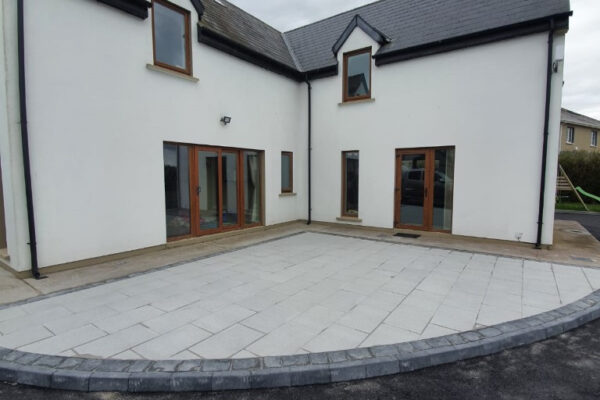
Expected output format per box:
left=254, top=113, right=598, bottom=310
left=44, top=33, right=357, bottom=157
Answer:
left=394, top=148, right=454, bottom=232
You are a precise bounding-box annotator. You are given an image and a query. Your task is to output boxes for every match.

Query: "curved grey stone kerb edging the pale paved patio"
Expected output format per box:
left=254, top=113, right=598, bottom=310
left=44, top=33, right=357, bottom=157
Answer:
left=0, top=291, right=600, bottom=392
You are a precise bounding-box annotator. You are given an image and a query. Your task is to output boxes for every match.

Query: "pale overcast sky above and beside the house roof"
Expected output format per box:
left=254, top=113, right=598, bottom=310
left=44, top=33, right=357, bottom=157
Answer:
left=229, top=0, right=600, bottom=119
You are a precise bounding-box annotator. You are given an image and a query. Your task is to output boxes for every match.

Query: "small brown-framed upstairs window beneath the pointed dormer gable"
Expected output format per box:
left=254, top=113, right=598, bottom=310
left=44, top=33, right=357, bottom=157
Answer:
left=343, top=47, right=371, bottom=102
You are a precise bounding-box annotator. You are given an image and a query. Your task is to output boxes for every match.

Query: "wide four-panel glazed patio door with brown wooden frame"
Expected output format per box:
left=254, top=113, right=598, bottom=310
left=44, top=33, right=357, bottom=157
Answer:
left=164, top=143, right=263, bottom=241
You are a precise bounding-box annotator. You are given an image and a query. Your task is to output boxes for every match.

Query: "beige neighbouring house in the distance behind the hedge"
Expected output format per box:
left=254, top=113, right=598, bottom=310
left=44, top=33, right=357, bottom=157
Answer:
left=560, top=108, right=600, bottom=152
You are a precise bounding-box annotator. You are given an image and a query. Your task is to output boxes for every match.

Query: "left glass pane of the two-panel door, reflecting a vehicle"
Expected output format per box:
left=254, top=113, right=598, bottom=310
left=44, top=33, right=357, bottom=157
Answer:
left=400, top=153, right=426, bottom=226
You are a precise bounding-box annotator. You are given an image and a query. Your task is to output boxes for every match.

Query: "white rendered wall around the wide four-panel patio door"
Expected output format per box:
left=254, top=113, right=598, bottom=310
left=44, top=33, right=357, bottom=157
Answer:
left=16, top=0, right=307, bottom=270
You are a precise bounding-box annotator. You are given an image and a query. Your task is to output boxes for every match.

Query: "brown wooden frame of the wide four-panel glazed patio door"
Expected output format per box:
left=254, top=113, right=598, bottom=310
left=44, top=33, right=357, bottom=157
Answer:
left=164, top=142, right=265, bottom=242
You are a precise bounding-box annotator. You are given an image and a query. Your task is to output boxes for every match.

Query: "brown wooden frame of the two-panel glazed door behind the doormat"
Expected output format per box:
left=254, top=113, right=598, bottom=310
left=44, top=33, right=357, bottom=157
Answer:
left=394, top=146, right=455, bottom=233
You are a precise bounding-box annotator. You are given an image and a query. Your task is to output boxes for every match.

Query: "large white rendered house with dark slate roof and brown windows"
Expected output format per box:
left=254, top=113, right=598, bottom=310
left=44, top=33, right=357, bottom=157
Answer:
left=0, top=0, right=571, bottom=275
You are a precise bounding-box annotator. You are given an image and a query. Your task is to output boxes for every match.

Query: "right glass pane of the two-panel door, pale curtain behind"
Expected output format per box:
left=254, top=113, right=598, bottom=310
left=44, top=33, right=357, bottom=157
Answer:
left=433, top=149, right=454, bottom=231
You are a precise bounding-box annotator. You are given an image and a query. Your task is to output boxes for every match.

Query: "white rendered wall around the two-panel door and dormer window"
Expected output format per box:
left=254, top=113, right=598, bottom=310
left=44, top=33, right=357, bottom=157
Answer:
left=313, top=29, right=564, bottom=244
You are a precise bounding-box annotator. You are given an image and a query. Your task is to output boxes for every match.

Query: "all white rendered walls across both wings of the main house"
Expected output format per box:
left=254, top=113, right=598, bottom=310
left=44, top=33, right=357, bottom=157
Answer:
left=0, top=0, right=564, bottom=271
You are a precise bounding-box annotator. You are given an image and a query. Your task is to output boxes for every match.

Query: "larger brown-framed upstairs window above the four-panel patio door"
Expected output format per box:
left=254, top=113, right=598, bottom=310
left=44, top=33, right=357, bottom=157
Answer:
left=152, top=0, right=192, bottom=75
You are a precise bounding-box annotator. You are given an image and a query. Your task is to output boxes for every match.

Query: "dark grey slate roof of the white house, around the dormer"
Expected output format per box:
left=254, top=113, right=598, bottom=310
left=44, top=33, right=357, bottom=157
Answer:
left=201, top=0, right=571, bottom=76
